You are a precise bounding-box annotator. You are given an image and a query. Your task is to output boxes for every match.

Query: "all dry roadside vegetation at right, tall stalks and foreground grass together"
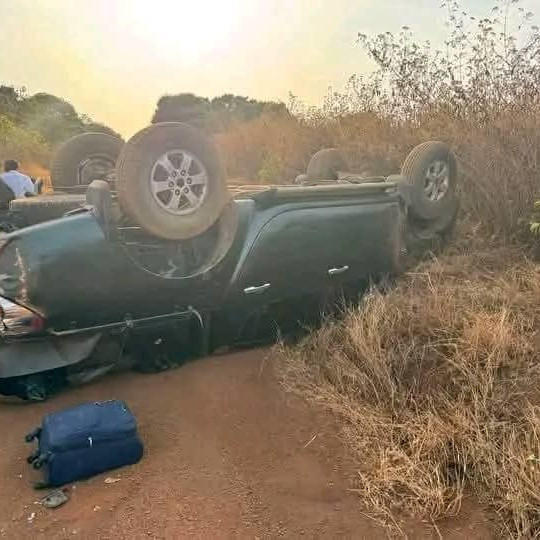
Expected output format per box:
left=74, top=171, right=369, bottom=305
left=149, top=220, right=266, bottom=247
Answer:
left=274, top=0, right=540, bottom=538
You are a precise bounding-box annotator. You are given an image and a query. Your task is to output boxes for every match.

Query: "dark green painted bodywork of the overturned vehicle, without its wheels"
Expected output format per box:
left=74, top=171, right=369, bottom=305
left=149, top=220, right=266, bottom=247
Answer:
left=0, top=182, right=404, bottom=392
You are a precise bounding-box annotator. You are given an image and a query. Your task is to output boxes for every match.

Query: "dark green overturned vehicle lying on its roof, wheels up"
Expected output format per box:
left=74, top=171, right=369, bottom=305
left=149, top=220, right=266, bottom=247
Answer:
left=0, top=123, right=458, bottom=400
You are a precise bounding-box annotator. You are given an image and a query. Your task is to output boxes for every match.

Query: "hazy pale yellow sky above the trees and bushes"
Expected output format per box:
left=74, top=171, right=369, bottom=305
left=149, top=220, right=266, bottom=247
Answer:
left=0, top=0, right=540, bottom=136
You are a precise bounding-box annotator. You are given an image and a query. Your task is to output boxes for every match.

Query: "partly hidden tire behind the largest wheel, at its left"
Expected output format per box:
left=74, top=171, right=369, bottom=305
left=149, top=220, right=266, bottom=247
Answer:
left=51, top=132, right=124, bottom=188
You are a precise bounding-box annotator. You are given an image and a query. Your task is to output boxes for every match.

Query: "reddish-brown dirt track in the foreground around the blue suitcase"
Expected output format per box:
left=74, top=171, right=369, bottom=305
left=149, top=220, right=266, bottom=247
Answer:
left=0, top=350, right=490, bottom=539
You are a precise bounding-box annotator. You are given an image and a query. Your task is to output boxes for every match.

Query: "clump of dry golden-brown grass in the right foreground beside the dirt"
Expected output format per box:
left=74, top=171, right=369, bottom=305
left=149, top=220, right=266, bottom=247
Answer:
left=279, top=251, right=540, bottom=538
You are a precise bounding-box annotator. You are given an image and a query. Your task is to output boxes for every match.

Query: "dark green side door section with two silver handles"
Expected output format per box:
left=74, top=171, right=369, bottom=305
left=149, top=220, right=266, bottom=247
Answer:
left=229, top=197, right=398, bottom=305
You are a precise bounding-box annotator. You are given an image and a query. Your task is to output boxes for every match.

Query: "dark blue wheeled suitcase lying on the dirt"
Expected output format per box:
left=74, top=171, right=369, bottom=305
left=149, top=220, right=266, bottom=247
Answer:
left=26, top=400, right=143, bottom=487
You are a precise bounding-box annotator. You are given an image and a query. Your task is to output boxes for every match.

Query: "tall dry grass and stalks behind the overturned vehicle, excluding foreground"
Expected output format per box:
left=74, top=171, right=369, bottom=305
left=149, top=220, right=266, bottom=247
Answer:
left=218, top=0, right=540, bottom=242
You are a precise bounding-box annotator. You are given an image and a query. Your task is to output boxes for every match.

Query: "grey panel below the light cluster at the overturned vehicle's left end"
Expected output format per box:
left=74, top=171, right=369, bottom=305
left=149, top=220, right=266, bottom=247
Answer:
left=0, top=334, right=101, bottom=379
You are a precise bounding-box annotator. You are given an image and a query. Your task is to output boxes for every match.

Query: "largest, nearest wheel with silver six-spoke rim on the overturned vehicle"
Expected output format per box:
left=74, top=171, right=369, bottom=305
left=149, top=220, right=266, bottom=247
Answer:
left=116, top=122, right=230, bottom=240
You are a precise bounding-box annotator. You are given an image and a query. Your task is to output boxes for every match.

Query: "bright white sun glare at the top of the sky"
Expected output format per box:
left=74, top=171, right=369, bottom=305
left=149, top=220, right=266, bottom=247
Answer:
left=128, top=0, right=243, bottom=61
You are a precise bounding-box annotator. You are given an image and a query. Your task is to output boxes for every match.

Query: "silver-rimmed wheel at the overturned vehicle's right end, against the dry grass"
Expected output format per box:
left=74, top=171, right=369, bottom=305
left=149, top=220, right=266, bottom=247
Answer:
left=401, top=141, right=457, bottom=220
